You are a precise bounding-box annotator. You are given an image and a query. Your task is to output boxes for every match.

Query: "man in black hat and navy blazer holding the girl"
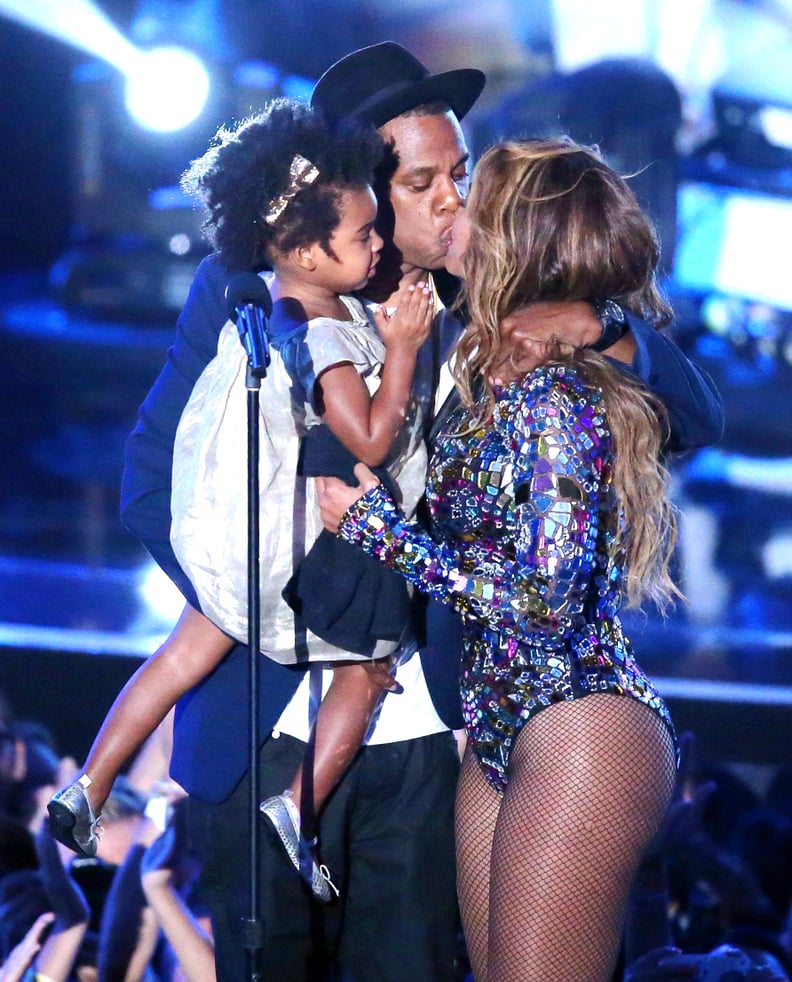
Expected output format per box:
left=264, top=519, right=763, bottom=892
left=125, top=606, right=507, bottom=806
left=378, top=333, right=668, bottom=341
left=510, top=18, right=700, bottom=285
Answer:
left=122, top=42, right=718, bottom=982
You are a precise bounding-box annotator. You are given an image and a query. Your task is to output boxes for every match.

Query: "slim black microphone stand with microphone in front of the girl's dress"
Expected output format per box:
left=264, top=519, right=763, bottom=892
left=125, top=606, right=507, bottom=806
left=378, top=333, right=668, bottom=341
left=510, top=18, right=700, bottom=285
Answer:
left=226, top=274, right=272, bottom=982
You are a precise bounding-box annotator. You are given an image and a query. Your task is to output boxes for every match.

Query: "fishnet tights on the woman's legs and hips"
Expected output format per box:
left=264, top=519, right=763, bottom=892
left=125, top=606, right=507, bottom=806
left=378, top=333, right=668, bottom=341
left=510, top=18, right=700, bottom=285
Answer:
left=457, top=693, right=676, bottom=982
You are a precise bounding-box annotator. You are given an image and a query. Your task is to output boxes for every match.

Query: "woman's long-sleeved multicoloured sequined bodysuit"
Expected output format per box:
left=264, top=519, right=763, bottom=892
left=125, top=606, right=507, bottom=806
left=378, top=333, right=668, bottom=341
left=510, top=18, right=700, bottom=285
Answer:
left=339, top=366, right=671, bottom=793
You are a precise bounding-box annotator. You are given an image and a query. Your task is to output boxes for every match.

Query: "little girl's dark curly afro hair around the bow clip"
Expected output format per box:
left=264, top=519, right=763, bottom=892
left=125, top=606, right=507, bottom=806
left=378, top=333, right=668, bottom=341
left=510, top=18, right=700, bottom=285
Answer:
left=182, top=99, right=384, bottom=272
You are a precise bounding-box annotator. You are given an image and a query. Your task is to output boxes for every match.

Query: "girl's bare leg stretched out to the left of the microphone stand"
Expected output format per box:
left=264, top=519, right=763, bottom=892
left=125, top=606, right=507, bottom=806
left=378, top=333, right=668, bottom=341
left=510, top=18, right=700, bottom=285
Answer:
left=84, top=606, right=234, bottom=812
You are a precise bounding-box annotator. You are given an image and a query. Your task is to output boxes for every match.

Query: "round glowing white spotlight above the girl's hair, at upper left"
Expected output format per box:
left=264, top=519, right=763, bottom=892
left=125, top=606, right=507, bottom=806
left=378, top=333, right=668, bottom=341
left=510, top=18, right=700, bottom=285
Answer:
left=126, top=47, right=209, bottom=133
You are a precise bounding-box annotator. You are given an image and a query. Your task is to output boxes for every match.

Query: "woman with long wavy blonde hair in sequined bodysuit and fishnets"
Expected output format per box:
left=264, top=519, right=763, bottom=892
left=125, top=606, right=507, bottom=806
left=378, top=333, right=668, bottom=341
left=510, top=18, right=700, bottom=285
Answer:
left=320, top=139, right=678, bottom=982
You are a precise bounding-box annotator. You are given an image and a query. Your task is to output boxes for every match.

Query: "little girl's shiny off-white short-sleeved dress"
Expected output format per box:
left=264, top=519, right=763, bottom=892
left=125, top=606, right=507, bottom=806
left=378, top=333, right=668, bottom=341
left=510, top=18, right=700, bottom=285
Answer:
left=171, top=288, right=427, bottom=664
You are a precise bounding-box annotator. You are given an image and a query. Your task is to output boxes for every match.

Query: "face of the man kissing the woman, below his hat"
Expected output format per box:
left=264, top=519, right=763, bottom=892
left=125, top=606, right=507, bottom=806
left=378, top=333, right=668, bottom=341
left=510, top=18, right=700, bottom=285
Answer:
left=380, top=112, right=470, bottom=273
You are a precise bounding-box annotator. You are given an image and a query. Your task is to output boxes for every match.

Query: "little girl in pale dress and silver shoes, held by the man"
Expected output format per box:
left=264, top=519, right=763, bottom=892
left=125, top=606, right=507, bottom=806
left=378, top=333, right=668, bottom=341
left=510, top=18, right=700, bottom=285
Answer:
left=49, top=99, right=432, bottom=900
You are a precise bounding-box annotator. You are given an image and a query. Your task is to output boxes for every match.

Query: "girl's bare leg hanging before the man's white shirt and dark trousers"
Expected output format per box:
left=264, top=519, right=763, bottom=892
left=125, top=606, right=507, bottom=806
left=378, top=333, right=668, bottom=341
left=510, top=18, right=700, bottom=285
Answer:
left=291, top=658, right=395, bottom=824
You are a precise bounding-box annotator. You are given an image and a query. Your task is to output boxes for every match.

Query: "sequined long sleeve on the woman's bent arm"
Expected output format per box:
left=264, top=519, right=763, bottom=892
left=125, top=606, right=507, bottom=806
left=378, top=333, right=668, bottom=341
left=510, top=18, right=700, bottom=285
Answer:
left=339, top=385, right=610, bottom=641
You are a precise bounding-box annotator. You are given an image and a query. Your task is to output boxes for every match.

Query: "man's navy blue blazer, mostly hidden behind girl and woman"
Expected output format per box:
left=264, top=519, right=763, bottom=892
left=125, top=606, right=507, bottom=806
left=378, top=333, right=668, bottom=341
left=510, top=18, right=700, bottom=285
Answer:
left=121, top=256, right=723, bottom=802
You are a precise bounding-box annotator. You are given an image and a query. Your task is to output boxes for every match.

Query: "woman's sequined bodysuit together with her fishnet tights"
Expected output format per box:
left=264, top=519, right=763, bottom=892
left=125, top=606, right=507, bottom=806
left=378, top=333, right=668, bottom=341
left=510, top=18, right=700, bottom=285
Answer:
left=340, top=366, right=675, bottom=982
